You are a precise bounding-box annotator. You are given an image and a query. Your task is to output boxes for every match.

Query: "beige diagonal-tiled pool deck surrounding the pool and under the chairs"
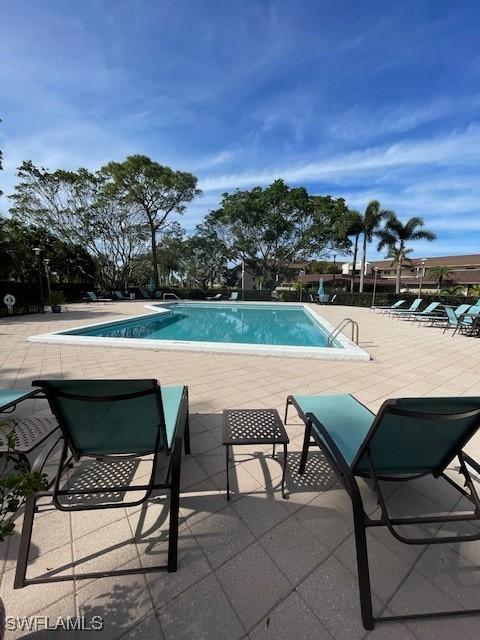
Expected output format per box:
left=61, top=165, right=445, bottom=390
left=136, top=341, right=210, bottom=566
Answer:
left=0, top=302, right=480, bottom=640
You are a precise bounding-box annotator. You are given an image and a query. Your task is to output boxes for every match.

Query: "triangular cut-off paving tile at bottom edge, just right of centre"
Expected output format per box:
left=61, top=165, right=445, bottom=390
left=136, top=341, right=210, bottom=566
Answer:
left=248, top=591, right=332, bottom=640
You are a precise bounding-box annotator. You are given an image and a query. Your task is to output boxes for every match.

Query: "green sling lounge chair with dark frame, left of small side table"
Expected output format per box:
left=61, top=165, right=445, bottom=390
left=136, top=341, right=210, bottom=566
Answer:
left=14, top=380, right=190, bottom=589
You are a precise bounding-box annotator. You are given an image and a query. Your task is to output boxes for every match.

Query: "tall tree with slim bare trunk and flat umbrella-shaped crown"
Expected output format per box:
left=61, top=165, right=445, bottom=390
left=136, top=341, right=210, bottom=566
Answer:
left=102, top=155, right=201, bottom=287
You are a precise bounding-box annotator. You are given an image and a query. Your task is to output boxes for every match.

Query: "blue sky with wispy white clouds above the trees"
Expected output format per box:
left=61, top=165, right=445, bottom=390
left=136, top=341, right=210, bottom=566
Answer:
left=0, top=0, right=480, bottom=257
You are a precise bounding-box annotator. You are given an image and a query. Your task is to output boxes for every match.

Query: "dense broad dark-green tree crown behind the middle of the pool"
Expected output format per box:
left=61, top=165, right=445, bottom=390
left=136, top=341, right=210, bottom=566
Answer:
left=207, top=180, right=349, bottom=283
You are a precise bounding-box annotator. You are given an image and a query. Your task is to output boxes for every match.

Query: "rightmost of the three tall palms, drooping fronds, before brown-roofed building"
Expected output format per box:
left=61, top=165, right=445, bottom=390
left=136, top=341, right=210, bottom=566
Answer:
left=377, top=211, right=437, bottom=293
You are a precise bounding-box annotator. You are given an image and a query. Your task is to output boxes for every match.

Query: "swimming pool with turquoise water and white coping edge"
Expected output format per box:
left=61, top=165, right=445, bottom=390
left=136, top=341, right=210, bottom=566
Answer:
left=30, top=302, right=369, bottom=360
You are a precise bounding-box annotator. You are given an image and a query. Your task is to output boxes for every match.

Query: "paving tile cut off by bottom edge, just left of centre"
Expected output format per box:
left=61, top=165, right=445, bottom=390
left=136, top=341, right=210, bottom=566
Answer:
left=158, top=575, right=245, bottom=640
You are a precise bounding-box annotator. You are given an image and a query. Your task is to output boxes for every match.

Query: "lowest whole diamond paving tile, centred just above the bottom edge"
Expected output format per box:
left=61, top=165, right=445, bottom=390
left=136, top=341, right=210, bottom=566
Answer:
left=216, top=543, right=291, bottom=630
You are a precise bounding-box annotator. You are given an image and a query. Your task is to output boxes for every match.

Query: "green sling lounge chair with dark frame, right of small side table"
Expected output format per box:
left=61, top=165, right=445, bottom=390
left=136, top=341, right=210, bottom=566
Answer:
left=285, top=394, right=480, bottom=629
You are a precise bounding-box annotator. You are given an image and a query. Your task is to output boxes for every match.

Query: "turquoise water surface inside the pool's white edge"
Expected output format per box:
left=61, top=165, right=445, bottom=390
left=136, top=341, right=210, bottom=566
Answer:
left=65, top=303, right=340, bottom=348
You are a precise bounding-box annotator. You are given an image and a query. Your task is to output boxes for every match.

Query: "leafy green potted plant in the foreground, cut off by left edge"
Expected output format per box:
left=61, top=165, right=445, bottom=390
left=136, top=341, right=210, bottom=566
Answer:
left=0, top=423, right=48, bottom=640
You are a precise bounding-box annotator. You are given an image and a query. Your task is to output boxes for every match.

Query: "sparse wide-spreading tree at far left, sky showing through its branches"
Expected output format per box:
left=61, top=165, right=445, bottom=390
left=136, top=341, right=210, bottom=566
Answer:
left=9, top=161, right=146, bottom=288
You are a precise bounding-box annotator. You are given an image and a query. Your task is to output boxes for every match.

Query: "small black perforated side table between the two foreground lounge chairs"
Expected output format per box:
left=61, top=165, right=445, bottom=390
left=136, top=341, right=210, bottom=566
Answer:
left=222, top=409, right=290, bottom=500
